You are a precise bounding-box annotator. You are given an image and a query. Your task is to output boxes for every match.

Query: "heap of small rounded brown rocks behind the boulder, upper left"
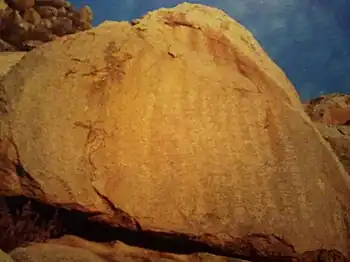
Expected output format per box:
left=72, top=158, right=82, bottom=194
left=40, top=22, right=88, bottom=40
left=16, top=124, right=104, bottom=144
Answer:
left=0, top=0, right=92, bottom=52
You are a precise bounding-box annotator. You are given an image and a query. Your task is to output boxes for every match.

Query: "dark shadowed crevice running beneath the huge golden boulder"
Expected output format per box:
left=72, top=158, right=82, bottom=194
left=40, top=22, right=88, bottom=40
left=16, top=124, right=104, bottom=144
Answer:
left=1, top=197, right=347, bottom=262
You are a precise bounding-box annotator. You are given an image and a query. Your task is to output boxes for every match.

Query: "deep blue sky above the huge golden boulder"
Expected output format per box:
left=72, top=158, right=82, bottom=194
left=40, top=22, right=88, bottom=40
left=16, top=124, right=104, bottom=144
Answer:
left=71, top=0, right=350, bottom=100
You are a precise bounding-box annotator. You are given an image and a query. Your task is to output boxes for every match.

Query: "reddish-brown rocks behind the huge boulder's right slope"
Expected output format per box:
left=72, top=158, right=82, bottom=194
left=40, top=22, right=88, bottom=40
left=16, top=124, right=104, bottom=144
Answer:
left=304, top=94, right=350, bottom=174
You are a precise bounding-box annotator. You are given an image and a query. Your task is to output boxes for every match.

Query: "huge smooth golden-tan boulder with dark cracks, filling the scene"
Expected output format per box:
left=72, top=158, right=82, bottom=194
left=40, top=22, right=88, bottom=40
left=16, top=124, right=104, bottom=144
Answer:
left=0, top=3, right=349, bottom=256
